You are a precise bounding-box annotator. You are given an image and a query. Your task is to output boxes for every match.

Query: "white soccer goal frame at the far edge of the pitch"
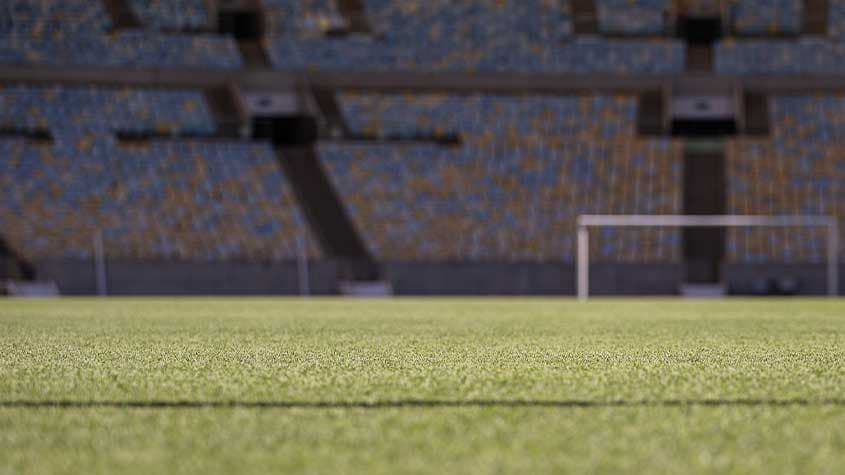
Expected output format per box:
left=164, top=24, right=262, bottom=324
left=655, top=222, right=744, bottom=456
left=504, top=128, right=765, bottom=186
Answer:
left=575, top=214, right=839, bottom=300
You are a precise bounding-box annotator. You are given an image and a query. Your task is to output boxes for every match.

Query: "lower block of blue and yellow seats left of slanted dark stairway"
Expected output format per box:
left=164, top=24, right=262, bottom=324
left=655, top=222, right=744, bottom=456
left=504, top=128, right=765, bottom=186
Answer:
left=0, top=138, right=317, bottom=261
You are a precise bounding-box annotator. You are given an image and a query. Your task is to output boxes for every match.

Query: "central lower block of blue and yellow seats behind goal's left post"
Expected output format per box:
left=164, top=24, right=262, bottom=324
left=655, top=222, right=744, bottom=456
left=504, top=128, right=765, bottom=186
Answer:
left=320, top=140, right=681, bottom=262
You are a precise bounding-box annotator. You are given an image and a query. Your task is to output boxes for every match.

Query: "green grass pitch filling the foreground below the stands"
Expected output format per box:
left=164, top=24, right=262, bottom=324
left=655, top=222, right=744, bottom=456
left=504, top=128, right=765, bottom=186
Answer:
left=0, top=299, right=845, bottom=474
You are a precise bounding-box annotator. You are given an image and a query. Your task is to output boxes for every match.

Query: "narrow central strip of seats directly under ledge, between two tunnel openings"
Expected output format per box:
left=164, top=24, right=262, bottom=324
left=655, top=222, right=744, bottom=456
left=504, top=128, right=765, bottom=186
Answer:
left=339, top=93, right=637, bottom=143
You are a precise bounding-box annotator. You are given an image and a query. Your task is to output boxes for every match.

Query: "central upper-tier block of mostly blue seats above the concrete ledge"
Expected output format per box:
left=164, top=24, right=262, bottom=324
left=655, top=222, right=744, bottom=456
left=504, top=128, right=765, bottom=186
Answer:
left=265, top=0, right=684, bottom=74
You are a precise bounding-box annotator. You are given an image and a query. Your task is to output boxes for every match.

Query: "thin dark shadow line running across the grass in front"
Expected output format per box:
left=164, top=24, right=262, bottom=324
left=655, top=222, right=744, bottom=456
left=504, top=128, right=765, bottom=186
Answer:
left=0, top=399, right=845, bottom=409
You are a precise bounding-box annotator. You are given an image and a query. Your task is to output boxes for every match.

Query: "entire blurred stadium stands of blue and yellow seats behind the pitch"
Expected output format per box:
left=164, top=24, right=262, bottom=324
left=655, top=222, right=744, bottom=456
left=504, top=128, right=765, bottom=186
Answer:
left=0, top=0, right=845, bottom=292
